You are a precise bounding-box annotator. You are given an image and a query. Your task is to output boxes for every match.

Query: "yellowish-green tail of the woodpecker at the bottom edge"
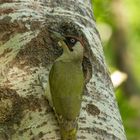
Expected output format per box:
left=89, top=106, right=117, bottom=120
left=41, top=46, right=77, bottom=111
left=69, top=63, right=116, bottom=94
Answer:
left=60, top=120, right=78, bottom=140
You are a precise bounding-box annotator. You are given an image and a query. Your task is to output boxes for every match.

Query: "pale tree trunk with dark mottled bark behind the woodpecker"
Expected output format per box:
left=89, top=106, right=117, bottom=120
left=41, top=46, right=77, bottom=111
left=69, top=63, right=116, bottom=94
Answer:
left=0, top=0, right=126, bottom=140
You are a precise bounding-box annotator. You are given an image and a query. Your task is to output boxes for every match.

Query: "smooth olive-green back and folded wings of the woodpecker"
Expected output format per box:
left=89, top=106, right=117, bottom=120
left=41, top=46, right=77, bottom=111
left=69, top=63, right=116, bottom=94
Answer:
left=49, top=61, right=83, bottom=120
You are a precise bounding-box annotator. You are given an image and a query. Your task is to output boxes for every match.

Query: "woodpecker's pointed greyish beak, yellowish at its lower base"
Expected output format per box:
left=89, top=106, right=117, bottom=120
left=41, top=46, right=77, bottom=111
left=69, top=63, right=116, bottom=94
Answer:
left=49, top=30, right=67, bottom=48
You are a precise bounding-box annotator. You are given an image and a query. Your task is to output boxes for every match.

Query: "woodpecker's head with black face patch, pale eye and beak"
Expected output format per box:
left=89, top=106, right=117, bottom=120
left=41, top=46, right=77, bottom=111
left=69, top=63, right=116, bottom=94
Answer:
left=51, top=31, right=84, bottom=60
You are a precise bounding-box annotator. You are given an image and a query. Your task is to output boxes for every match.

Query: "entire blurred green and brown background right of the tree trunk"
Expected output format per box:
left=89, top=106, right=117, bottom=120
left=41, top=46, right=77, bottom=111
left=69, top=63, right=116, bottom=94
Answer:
left=92, top=0, right=140, bottom=140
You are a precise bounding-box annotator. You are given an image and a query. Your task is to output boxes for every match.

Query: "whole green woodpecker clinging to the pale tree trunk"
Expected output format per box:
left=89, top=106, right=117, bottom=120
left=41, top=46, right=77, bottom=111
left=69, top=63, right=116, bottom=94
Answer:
left=47, top=33, right=84, bottom=140
